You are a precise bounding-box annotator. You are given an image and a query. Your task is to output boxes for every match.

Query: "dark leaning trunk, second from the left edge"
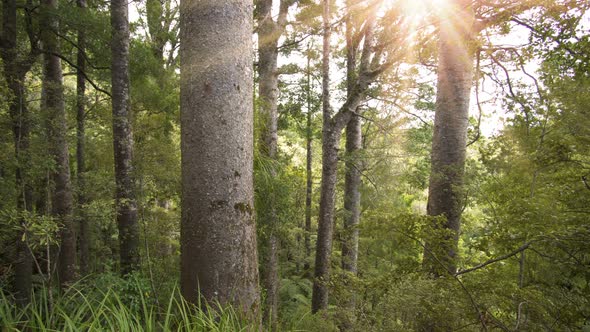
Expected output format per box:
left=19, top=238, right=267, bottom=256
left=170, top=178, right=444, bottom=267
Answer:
left=41, top=0, right=76, bottom=285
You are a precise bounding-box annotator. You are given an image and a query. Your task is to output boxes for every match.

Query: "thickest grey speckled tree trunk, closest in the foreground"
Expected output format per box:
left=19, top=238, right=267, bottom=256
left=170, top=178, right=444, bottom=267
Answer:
left=180, top=0, right=260, bottom=315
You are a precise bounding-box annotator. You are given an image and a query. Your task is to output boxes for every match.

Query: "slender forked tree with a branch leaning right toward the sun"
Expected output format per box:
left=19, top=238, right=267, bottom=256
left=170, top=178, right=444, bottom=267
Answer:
left=311, top=2, right=404, bottom=313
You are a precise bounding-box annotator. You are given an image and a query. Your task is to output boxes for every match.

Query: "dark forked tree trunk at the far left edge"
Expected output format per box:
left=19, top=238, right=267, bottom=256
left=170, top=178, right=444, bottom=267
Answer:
left=0, top=0, right=36, bottom=305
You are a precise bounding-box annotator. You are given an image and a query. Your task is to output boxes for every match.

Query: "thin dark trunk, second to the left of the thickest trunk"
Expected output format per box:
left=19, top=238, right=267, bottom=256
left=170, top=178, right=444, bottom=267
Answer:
left=76, top=0, right=90, bottom=276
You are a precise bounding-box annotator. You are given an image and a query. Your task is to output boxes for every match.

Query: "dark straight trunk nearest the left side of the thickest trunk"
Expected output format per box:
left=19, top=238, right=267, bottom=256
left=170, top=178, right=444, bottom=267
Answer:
left=111, top=0, right=139, bottom=275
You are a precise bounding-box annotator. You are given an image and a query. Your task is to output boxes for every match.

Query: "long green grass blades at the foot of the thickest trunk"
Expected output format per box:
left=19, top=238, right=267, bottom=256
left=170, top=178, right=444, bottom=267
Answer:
left=0, top=279, right=252, bottom=332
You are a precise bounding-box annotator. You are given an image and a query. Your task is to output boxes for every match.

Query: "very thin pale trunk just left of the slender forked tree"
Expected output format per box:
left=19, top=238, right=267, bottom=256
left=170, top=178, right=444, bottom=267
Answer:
left=303, top=50, right=313, bottom=274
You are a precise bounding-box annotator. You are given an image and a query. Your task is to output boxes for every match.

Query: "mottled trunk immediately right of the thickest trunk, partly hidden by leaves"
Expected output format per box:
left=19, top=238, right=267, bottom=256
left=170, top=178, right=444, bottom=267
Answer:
left=257, top=0, right=289, bottom=331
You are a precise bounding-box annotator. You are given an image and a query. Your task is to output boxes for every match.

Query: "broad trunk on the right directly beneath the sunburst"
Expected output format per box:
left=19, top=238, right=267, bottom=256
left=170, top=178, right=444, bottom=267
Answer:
left=423, top=0, right=475, bottom=276
